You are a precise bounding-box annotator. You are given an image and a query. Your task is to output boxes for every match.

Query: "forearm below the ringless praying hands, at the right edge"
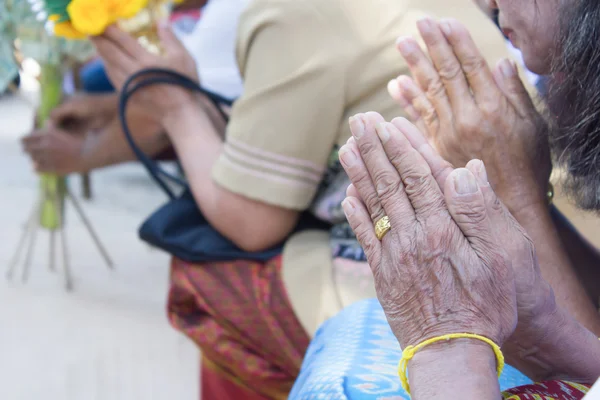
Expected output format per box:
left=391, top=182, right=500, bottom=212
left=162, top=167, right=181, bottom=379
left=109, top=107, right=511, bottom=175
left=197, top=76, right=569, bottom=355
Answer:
left=511, top=204, right=600, bottom=334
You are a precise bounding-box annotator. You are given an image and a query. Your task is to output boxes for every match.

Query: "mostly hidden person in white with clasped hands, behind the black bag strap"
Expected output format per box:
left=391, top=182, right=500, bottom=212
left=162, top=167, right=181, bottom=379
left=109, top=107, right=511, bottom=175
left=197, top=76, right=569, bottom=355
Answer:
left=23, top=0, right=245, bottom=175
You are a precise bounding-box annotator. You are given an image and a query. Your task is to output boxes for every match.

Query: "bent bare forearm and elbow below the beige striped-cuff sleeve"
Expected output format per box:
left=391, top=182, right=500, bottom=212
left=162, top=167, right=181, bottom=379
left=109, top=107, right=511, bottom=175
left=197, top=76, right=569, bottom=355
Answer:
left=163, top=101, right=298, bottom=251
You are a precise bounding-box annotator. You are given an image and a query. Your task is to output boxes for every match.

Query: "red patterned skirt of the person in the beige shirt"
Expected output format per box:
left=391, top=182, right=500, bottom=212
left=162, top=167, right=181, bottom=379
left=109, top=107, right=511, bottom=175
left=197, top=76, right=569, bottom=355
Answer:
left=168, top=257, right=309, bottom=400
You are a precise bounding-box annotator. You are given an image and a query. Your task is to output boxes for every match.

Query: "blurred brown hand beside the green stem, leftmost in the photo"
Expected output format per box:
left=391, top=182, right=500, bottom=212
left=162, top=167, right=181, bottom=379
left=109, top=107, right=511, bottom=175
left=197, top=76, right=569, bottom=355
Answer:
left=22, top=126, right=86, bottom=175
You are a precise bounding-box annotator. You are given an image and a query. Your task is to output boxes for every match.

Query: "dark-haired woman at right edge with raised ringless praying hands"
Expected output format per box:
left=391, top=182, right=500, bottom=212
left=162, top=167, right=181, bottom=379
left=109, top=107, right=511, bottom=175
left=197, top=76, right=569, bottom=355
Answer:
left=390, top=0, right=600, bottom=335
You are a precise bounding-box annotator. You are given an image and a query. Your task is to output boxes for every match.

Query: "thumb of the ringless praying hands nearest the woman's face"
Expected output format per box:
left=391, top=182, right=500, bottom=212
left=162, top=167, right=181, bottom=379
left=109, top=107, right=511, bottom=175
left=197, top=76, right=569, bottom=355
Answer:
left=494, top=59, right=535, bottom=113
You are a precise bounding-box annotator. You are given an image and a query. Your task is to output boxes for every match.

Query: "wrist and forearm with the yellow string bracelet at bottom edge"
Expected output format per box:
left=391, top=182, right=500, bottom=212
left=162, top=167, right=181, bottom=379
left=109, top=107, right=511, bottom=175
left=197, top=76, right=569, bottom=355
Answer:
left=408, top=339, right=502, bottom=400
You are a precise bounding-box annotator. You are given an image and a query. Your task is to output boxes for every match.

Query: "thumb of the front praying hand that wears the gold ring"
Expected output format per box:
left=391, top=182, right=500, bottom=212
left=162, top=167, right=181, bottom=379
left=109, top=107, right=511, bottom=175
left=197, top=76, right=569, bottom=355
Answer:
left=444, top=168, right=492, bottom=247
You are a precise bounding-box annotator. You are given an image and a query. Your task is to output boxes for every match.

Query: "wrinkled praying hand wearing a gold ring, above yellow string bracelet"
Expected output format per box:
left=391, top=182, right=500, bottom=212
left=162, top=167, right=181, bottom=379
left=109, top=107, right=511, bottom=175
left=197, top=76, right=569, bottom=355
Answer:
left=340, top=113, right=524, bottom=346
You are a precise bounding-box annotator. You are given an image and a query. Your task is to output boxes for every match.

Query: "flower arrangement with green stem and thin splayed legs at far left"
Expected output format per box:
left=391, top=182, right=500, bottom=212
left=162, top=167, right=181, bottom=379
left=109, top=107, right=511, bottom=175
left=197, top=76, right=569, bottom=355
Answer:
left=0, top=0, right=112, bottom=289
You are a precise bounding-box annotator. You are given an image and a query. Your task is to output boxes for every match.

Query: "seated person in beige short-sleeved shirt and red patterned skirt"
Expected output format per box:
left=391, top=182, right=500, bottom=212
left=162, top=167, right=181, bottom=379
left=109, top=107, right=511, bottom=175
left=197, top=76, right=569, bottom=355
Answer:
left=25, top=0, right=528, bottom=399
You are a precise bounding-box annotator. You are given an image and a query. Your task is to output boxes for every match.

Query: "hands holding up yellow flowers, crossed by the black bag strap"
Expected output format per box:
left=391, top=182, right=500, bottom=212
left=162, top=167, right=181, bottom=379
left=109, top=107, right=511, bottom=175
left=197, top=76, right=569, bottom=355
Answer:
left=92, top=26, right=198, bottom=120
